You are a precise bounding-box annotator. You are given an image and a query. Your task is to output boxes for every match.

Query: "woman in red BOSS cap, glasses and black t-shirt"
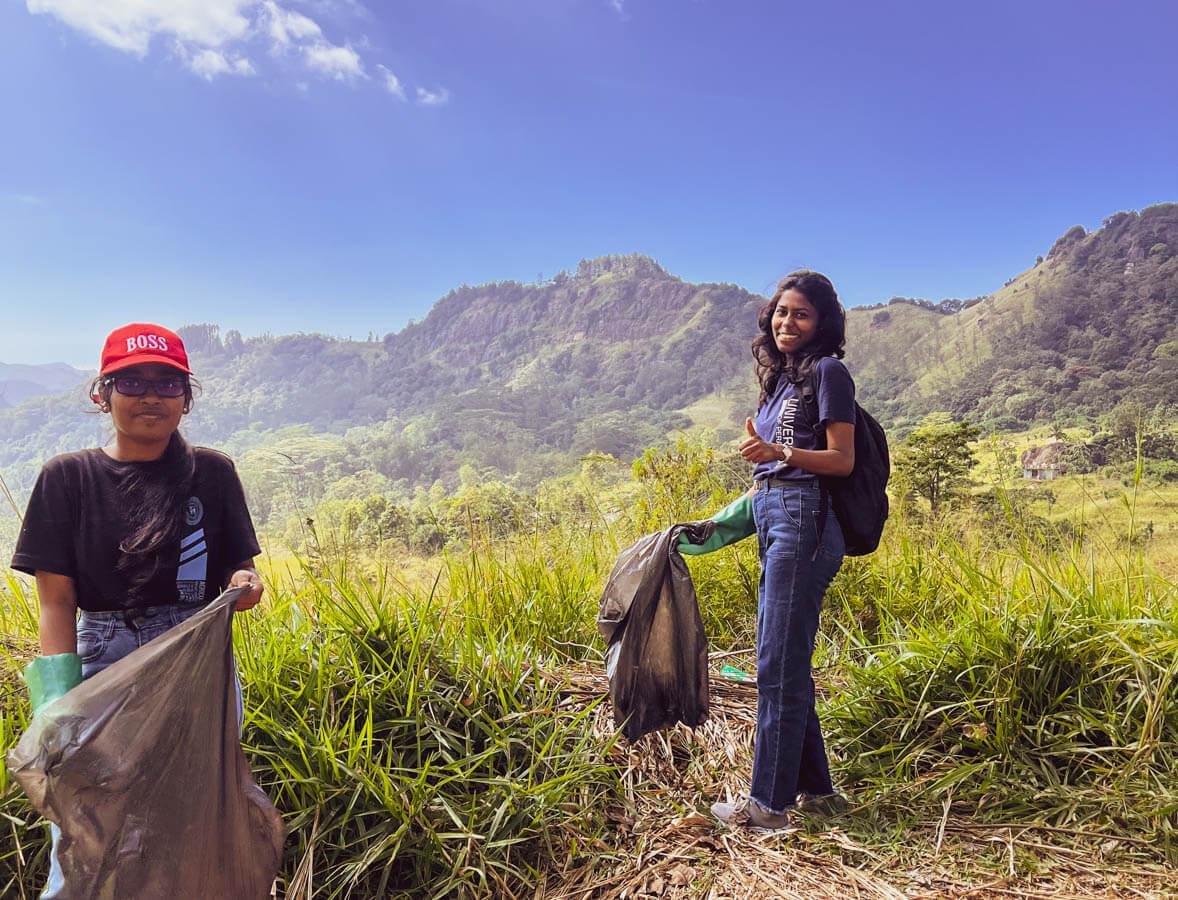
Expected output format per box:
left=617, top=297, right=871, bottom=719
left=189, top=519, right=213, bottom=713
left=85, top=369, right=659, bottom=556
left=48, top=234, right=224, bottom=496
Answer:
left=12, top=324, right=263, bottom=898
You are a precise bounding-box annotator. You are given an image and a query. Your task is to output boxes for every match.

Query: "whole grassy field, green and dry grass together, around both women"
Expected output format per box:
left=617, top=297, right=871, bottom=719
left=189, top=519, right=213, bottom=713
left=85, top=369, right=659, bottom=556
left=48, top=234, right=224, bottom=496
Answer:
left=0, top=459, right=1178, bottom=898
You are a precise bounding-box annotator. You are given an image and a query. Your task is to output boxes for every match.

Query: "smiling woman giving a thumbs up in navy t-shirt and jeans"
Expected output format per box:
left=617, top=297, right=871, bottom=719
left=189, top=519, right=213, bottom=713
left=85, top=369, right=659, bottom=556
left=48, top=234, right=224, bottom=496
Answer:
left=712, top=271, right=856, bottom=829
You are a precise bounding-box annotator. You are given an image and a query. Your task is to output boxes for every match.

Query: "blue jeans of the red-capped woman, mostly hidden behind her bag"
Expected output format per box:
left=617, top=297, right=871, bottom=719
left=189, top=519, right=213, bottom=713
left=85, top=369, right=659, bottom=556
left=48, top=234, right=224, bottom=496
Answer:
left=41, top=605, right=245, bottom=900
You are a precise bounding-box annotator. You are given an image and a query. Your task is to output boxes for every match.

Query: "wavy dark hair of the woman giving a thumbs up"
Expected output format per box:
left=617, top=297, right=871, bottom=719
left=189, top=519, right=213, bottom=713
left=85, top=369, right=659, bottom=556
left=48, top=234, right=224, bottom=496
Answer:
left=753, top=269, right=847, bottom=406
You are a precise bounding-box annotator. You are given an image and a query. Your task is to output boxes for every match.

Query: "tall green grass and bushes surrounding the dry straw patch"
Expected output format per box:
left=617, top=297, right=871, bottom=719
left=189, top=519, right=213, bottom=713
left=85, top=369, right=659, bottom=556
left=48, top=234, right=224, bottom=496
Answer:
left=0, top=437, right=1178, bottom=896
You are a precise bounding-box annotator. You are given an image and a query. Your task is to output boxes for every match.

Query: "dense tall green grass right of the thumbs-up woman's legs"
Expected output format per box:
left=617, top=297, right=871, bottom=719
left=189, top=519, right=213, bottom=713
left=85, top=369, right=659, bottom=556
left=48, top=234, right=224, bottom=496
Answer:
left=825, top=527, right=1178, bottom=854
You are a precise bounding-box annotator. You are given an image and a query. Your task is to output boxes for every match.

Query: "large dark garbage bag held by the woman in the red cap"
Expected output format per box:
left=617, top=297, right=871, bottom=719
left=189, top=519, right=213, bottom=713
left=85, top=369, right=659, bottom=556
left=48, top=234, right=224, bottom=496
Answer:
left=8, top=589, right=284, bottom=900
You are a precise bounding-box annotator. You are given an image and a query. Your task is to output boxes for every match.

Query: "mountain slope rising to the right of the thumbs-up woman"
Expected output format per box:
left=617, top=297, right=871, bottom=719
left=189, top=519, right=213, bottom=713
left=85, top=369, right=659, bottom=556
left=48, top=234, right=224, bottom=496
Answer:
left=847, top=204, right=1178, bottom=429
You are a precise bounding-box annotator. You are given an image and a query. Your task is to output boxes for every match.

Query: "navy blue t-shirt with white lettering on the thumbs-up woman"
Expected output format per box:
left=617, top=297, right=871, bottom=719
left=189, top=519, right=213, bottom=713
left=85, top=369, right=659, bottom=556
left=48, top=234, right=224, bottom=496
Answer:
left=753, top=356, right=855, bottom=481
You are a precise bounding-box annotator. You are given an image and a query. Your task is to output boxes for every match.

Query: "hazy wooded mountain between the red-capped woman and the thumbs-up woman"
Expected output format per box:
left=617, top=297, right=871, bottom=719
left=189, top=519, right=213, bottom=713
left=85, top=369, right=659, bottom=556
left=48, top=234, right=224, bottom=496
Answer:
left=181, top=256, right=763, bottom=440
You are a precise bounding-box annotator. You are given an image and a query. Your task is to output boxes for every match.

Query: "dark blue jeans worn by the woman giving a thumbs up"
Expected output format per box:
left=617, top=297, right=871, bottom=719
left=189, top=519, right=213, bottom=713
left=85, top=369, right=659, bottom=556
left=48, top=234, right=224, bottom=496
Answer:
left=749, top=481, right=846, bottom=813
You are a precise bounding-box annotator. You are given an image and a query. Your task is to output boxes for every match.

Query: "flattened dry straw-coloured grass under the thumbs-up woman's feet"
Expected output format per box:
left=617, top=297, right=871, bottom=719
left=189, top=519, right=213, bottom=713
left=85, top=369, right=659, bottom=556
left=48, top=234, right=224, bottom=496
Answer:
left=536, top=668, right=1178, bottom=900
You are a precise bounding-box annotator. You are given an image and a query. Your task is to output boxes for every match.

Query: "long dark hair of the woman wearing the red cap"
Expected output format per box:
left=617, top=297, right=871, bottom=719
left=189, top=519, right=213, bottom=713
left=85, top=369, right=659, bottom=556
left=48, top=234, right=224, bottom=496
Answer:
left=91, top=378, right=197, bottom=601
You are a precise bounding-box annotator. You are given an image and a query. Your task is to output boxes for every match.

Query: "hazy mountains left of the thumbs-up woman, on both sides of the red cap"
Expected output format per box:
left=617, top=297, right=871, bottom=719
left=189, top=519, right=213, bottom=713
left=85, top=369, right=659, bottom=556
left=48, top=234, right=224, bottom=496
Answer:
left=0, top=256, right=763, bottom=494
